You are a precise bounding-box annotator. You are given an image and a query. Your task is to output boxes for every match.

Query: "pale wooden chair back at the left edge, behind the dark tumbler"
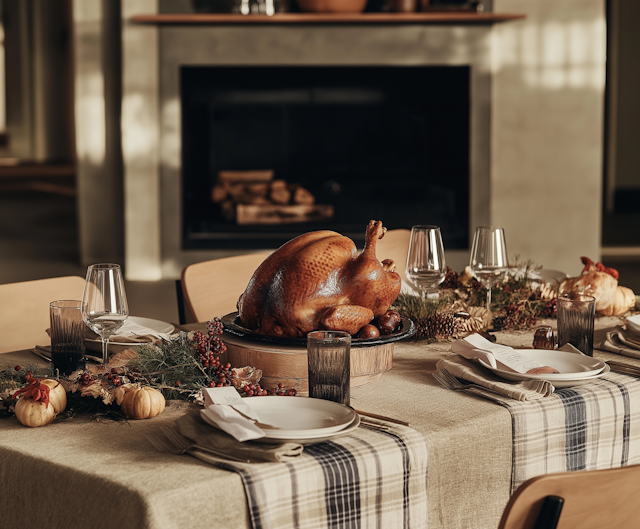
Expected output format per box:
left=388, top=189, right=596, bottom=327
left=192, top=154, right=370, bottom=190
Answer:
left=0, top=276, right=85, bottom=353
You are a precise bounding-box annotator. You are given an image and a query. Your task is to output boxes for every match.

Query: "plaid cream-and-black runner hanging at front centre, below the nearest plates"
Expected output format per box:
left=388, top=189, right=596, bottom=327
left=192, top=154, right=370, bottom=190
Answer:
left=212, top=423, right=427, bottom=529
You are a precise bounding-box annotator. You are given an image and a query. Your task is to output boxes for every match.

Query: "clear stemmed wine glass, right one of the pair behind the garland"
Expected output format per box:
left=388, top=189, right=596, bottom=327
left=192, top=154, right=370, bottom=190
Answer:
left=469, top=226, right=509, bottom=311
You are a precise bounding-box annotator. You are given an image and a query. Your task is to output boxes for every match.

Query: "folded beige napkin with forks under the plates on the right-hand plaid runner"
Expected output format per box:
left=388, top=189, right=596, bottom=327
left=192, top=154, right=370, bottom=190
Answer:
left=436, top=356, right=554, bottom=401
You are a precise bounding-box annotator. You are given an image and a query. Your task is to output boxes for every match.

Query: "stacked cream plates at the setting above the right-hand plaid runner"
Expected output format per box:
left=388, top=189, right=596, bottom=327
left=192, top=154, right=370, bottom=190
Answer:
left=478, top=349, right=611, bottom=388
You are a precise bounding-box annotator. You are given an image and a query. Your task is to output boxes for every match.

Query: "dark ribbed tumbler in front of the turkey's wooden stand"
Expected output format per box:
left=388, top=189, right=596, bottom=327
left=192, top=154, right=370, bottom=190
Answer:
left=307, top=331, right=351, bottom=406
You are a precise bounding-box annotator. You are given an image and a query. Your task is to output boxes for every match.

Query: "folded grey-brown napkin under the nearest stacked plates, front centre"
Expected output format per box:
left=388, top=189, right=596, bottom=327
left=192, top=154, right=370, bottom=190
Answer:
left=175, top=412, right=303, bottom=463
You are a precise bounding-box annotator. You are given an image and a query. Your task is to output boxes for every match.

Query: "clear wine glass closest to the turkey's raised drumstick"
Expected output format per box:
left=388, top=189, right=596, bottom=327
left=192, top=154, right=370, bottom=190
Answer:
left=405, top=226, right=447, bottom=299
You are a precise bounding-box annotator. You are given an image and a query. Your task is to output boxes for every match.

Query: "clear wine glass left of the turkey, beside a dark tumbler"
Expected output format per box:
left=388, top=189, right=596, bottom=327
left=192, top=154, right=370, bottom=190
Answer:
left=82, top=263, right=129, bottom=369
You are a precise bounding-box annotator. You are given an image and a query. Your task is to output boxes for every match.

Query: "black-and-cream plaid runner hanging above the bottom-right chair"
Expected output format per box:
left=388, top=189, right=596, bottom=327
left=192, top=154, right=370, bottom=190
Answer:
left=504, top=373, right=640, bottom=491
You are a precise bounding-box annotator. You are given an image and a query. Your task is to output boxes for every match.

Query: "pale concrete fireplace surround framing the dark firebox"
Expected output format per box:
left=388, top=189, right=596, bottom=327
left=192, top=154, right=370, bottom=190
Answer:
left=76, top=0, right=606, bottom=280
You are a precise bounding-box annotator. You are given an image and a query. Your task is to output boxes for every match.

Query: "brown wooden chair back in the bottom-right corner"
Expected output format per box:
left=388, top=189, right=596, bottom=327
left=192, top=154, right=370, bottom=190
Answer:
left=499, top=465, right=640, bottom=529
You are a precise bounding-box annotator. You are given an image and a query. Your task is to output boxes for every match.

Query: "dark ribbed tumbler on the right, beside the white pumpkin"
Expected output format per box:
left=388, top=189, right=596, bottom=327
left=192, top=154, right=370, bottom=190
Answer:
left=557, top=294, right=596, bottom=356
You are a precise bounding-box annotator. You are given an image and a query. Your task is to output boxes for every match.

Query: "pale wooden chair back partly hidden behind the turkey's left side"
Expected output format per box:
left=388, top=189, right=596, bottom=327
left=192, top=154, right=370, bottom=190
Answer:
left=180, top=252, right=269, bottom=323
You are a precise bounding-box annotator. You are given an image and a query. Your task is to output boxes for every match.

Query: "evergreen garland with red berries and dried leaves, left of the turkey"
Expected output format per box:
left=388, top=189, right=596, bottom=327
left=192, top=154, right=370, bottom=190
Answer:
left=0, top=318, right=297, bottom=425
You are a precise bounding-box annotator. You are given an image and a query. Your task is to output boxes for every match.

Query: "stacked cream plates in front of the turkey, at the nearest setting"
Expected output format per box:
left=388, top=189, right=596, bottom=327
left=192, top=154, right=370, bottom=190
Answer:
left=200, top=396, right=360, bottom=444
